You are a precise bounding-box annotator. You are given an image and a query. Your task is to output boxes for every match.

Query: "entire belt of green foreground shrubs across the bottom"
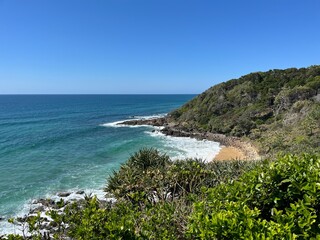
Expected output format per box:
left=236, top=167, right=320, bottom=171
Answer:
left=9, top=149, right=320, bottom=239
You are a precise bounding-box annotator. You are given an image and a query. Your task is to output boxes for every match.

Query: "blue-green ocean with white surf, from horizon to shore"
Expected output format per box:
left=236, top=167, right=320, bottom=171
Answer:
left=0, top=95, right=219, bottom=233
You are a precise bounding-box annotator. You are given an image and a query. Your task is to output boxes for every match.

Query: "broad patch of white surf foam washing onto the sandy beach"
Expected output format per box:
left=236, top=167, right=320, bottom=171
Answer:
left=145, top=131, right=221, bottom=162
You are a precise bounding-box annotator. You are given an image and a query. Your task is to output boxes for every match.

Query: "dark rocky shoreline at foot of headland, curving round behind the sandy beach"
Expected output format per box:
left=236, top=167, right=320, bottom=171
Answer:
left=119, top=117, right=261, bottom=160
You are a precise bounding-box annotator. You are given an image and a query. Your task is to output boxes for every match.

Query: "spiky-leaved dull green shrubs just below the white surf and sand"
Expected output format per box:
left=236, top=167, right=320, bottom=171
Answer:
left=106, top=149, right=255, bottom=205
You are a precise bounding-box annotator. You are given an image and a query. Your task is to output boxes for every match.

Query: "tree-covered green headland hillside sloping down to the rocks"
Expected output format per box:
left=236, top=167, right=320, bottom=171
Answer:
left=170, top=66, right=320, bottom=156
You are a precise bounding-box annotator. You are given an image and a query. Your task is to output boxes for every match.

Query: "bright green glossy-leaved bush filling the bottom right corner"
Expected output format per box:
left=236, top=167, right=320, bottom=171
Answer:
left=188, top=155, right=320, bottom=239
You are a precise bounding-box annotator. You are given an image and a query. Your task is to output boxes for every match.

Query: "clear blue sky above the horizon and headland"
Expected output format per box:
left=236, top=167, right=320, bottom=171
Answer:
left=0, top=0, right=320, bottom=94
